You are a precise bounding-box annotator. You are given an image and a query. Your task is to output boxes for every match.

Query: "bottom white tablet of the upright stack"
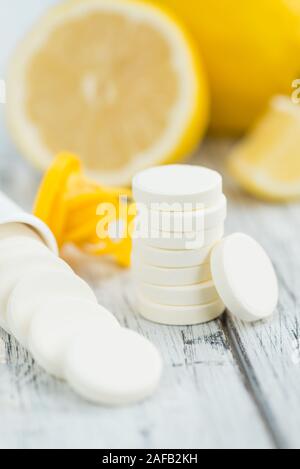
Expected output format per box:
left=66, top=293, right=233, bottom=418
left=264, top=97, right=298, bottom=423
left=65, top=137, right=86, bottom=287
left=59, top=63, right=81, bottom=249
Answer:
left=137, top=296, right=225, bottom=326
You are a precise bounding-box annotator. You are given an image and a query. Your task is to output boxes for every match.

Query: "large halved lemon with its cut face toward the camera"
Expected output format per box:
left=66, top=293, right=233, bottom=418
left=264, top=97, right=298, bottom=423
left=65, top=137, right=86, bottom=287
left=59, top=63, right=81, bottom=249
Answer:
left=7, top=0, right=208, bottom=185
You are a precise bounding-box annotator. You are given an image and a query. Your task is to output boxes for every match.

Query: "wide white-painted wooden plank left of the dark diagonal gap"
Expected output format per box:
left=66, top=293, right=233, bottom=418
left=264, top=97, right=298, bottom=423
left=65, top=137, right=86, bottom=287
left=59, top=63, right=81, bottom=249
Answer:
left=0, top=140, right=274, bottom=448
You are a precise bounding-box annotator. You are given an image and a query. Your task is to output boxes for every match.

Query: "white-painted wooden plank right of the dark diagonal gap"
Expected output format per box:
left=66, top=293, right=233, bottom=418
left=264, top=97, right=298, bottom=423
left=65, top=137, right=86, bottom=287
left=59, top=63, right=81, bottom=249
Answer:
left=199, top=142, right=300, bottom=448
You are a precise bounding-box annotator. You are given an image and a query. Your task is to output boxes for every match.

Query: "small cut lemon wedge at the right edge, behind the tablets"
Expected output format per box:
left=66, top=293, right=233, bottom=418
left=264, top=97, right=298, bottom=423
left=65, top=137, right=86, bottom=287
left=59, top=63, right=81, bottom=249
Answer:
left=229, top=96, right=300, bottom=201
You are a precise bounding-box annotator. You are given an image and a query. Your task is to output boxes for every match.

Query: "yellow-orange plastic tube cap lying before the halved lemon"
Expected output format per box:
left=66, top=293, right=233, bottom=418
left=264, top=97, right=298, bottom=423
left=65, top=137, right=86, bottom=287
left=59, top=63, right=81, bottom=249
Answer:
left=33, top=153, right=136, bottom=267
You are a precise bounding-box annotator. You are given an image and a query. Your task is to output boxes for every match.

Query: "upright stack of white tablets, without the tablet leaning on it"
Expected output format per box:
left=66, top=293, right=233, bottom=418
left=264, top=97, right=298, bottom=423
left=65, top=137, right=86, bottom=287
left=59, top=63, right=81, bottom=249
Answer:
left=132, top=165, right=227, bottom=324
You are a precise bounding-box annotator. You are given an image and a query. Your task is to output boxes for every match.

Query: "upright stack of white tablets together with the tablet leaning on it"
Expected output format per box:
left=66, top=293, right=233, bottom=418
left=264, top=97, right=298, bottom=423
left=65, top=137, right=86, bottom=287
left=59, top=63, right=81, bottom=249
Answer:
left=132, top=165, right=278, bottom=325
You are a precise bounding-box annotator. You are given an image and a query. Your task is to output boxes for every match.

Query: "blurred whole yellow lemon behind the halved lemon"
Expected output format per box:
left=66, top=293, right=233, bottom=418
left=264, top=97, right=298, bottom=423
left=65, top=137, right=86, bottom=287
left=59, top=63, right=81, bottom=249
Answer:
left=151, top=0, right=300, bottom=133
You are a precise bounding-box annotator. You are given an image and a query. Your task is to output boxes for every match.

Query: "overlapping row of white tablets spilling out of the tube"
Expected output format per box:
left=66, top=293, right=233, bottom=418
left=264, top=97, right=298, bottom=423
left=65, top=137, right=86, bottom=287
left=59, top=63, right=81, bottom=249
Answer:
left=0, top=223, right=162, bottom=405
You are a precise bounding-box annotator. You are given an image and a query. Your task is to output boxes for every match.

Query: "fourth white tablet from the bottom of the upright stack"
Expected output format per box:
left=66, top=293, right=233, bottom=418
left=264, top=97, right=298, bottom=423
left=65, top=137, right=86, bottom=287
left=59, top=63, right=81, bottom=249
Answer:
left=132, top=239, right=214, bottom=268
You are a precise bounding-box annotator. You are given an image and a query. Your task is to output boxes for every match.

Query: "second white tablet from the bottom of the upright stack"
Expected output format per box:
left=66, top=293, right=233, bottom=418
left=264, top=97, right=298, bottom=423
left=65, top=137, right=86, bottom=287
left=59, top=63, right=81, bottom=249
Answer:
left=137, top=280, right=219, bottom=306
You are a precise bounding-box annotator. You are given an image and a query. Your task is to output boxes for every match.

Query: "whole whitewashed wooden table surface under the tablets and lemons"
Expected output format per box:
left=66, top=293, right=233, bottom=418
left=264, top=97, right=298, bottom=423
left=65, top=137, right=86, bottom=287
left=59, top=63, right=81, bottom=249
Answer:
left=0, top=142, right=300, bottom=448
